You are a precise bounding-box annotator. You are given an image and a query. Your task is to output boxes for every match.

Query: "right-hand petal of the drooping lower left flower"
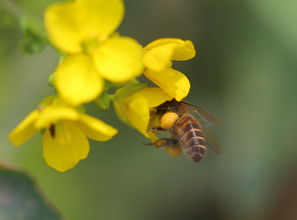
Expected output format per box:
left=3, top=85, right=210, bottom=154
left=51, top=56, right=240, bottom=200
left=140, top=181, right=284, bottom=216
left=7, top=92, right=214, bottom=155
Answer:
left=76, top=114, right=118, bottom=141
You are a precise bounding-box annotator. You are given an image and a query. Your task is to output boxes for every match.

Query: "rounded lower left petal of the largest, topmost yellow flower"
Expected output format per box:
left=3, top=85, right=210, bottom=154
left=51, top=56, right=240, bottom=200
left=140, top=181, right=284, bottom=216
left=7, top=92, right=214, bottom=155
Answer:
left=55, top=55, right=103, bottom=106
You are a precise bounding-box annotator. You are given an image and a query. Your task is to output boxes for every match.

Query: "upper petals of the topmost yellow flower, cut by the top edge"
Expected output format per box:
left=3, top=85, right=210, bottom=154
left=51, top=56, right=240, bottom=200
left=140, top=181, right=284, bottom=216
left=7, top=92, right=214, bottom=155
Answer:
left=45, top=0, right=124, bottom=53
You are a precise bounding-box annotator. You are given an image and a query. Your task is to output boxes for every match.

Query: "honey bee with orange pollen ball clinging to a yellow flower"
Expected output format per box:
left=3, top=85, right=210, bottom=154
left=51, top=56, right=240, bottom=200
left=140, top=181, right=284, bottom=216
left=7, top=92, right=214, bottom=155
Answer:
left=150, top=99, right=220, bottom=163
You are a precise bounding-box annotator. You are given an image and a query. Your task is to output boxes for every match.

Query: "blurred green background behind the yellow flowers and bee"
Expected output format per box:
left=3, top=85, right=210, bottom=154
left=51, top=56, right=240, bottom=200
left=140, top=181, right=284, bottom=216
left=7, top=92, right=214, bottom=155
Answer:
left=0, top=0, right=297, bottom=220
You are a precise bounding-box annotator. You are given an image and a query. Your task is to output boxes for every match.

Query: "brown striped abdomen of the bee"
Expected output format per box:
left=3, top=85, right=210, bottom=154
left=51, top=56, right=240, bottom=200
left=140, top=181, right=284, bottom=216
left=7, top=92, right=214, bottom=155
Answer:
left=172, top=114, right=206, bottom=163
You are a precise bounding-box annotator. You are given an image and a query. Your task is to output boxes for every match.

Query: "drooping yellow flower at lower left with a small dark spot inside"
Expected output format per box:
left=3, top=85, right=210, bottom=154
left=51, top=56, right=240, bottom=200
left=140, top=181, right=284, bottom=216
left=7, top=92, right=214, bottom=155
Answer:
left=9, top=96, right=117, bottom=172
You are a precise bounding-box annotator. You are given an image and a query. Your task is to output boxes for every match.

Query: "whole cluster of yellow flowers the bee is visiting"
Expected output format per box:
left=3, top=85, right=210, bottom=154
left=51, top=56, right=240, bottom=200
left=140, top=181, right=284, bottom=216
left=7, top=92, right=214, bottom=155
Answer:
left=9, top=0, right=195, bottom=172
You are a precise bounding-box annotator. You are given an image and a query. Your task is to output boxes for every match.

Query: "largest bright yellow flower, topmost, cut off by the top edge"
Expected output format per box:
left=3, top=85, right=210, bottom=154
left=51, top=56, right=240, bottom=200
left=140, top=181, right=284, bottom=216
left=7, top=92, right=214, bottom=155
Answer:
left=45, top=0, right=143, bottom=106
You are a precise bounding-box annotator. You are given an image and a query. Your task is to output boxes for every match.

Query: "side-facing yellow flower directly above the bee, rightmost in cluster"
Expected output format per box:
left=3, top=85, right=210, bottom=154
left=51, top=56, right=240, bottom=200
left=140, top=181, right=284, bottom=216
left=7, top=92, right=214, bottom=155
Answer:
left=143, top=38, right=196, bottom=101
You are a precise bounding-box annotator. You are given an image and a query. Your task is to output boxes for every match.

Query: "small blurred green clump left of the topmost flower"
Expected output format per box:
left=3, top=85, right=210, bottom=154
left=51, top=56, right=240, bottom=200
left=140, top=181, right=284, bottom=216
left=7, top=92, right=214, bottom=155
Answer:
left=20, top=16, right=47, bottom=54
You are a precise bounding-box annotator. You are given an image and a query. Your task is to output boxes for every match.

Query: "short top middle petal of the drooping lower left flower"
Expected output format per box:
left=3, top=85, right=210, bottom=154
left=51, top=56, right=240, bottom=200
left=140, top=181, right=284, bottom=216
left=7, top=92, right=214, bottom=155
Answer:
left=35, top=106, right=79, bottom=129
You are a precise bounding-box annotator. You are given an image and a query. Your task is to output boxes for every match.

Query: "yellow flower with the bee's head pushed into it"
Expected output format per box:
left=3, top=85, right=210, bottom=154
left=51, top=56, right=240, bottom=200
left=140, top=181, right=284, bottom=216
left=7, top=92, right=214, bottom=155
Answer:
left=113, top=88, right=172, bottom=140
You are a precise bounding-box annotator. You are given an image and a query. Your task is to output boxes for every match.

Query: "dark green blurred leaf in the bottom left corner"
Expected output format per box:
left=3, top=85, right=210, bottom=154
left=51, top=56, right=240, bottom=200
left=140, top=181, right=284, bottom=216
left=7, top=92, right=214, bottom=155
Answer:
left=0, top=165, right=62, bottom=220
